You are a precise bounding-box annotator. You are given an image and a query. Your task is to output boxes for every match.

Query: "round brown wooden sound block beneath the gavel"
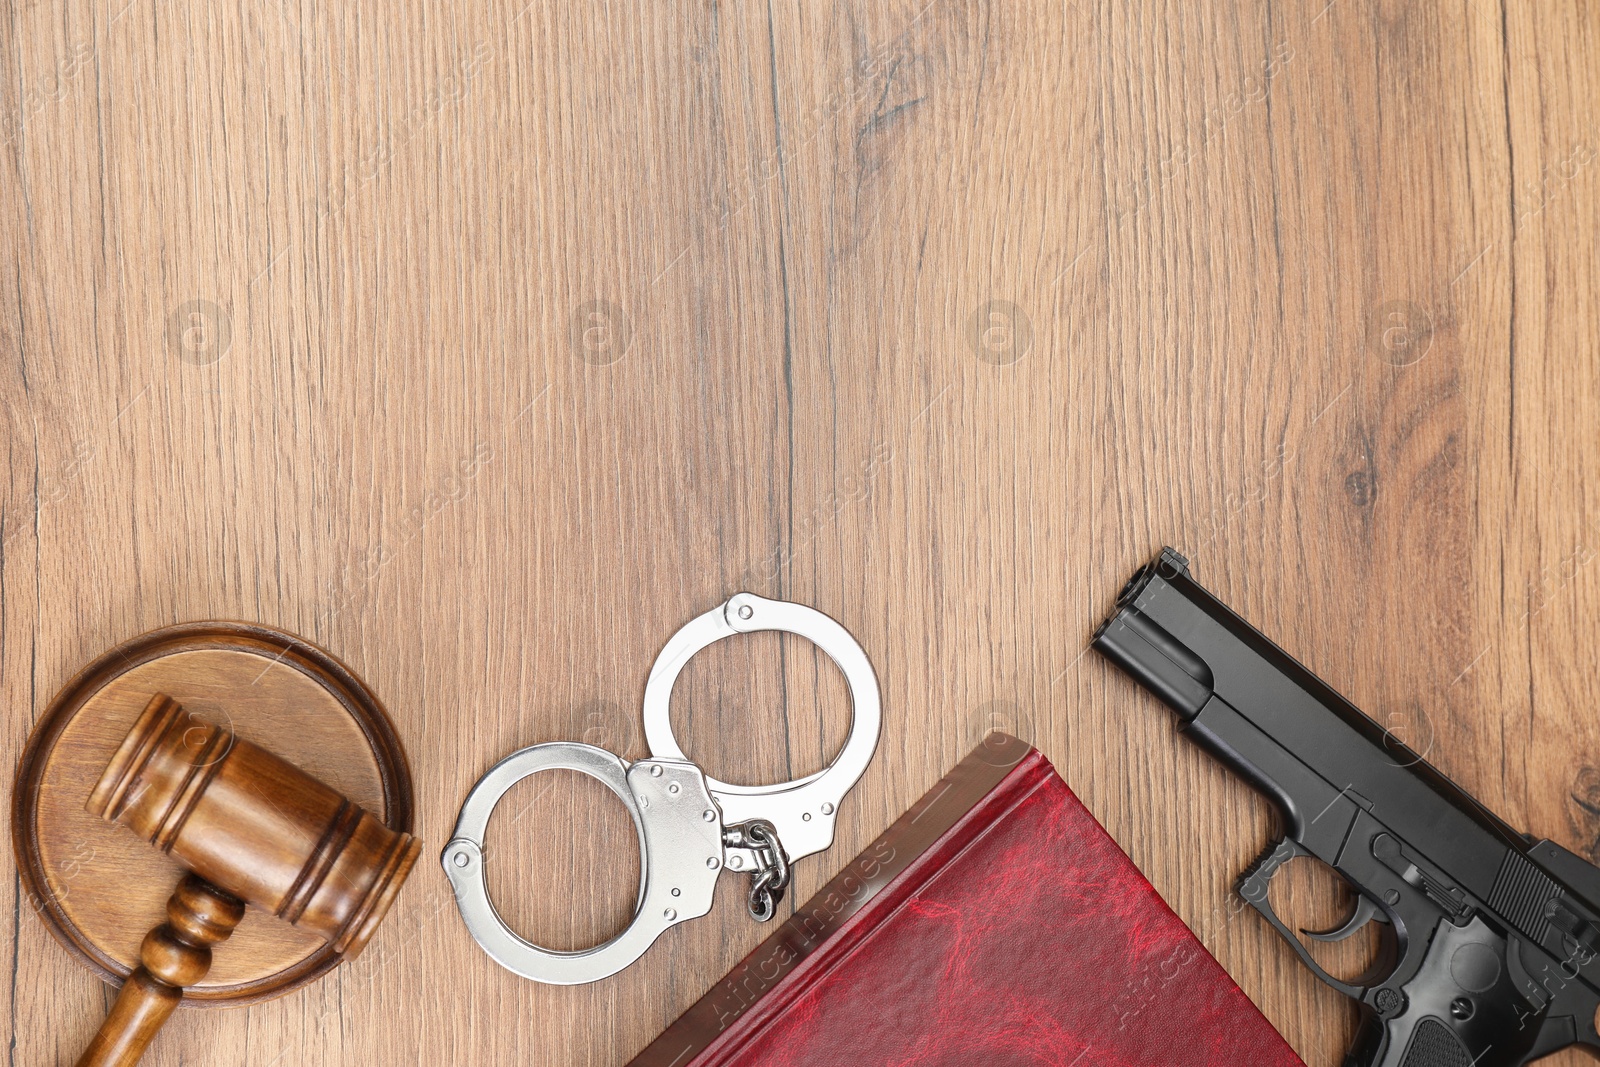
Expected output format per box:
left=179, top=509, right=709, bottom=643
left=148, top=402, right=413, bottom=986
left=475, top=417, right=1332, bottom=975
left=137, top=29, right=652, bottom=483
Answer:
left=11, top=622, right=413, bottom=1005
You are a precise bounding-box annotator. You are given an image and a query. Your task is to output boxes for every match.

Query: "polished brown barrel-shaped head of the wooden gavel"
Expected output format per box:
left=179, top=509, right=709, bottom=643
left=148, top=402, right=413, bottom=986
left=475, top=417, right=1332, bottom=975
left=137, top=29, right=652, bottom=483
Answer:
left=86, top=694, right=421, bottom=957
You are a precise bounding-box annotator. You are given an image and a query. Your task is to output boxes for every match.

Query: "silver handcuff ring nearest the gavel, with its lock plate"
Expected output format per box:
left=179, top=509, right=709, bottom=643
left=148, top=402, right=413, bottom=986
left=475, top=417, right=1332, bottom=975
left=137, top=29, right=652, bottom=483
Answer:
left=440, top=741, right=723, bottom=985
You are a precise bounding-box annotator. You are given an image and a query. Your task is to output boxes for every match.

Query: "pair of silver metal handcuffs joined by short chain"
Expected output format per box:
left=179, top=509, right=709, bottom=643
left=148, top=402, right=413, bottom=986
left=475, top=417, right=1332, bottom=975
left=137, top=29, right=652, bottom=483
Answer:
left=440, top=593, right=882, bottom=985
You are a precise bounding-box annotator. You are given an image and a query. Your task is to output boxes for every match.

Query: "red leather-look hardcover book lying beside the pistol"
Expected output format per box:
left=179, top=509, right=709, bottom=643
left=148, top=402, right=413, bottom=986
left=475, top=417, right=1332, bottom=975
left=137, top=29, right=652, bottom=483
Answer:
left=632, top=734, right=1304, bottom=1067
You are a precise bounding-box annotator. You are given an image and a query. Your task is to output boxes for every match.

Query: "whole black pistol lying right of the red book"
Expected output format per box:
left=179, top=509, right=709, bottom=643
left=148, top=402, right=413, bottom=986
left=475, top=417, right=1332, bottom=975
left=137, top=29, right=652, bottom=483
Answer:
left=1094, top=549, right=1600, bottom=1067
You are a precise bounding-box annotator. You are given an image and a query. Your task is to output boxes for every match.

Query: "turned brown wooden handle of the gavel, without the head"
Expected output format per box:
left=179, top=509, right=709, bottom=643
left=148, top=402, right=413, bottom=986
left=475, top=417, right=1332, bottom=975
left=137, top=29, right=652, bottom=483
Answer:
left=78, top=875, right=245, bottom=1067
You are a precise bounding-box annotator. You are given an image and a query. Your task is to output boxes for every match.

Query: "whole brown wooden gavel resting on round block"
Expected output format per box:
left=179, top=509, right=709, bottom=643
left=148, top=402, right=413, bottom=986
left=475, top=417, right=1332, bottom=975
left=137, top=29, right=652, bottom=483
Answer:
left=78, top=694, right=421, bottom=1067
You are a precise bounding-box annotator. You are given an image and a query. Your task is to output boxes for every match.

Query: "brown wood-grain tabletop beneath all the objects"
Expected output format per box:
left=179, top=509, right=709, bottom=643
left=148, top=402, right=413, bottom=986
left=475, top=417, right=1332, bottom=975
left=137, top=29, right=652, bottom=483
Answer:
left=0, top=0, right=1600, bottom=1067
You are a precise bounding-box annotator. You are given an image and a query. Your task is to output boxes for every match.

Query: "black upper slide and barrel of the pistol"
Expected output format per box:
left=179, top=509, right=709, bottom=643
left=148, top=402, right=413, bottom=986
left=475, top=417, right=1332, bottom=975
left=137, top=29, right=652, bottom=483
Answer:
left=1093, top=549, right=1548, bottom=901
